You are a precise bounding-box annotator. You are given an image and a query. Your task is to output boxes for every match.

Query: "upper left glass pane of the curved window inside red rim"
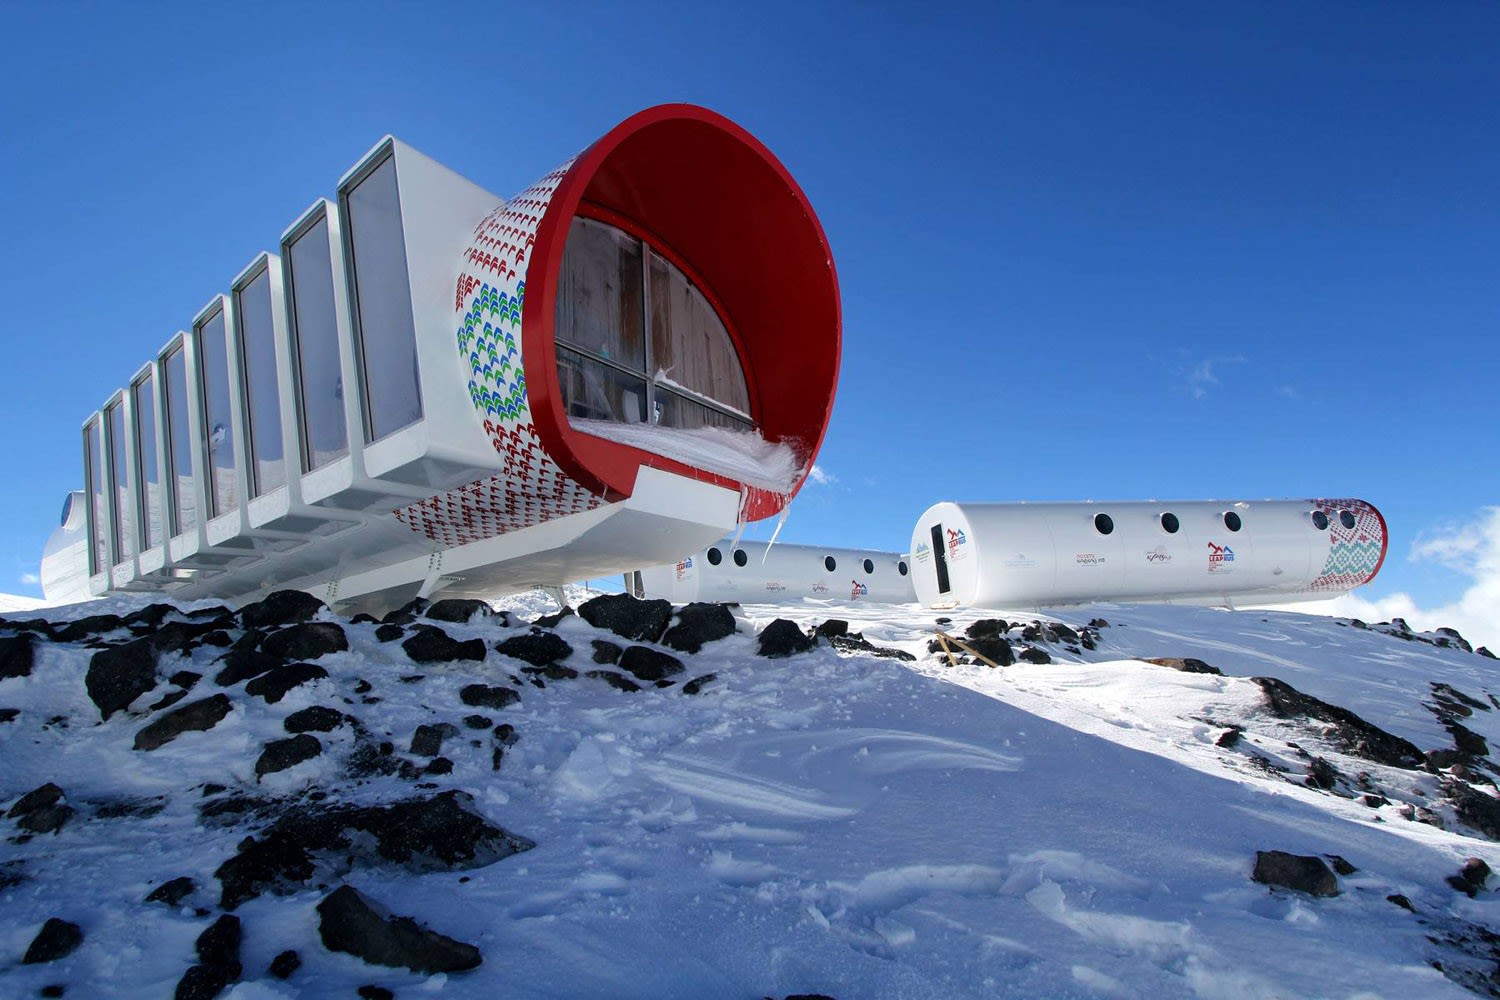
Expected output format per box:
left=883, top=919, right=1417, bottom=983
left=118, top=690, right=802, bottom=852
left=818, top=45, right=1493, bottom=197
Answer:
left=557, top=219, right=645, bottom=372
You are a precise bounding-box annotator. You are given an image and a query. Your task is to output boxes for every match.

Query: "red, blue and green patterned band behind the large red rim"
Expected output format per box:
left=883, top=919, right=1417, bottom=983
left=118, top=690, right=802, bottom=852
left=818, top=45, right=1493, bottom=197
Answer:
left=396, top=160, right=603, bottom=546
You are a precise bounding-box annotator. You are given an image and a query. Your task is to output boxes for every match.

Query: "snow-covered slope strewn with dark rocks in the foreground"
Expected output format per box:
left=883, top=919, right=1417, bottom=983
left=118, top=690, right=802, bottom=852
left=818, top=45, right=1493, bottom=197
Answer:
left=0, top=598, right=1500, bottom=999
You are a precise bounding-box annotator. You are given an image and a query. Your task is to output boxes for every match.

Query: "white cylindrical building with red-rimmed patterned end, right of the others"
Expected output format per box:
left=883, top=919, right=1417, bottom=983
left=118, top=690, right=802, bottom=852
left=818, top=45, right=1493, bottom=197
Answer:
left=912, top=499, right=1389, bottom=607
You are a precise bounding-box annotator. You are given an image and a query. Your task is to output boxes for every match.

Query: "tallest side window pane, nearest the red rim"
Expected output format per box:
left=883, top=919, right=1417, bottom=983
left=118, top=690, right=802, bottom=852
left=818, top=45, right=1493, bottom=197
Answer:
left=348, top=157, right=422, bottom=441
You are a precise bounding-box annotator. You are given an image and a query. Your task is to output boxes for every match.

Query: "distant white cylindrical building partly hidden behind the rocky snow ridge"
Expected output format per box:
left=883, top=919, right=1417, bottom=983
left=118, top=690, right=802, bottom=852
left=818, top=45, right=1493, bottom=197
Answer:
left=641, top=541, right=917, bottom=604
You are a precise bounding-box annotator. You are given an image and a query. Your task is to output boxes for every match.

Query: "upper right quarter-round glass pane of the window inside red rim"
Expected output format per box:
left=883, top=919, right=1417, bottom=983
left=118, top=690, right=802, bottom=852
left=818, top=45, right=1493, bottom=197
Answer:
left=651, top=252, right=750, bottom=417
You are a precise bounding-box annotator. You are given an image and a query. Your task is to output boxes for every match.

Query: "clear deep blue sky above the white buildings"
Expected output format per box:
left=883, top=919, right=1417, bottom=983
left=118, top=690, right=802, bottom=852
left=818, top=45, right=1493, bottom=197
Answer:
left=0, top=0, right=1500, bottom=632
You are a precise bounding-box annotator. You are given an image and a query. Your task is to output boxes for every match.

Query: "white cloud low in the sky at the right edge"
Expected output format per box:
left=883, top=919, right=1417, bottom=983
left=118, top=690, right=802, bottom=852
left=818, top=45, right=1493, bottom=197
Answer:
left=1286, top=507, right=1500, bottom=652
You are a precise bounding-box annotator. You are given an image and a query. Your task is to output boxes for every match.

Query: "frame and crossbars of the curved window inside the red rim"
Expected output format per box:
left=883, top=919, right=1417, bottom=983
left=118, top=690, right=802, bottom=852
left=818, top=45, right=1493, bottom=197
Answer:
left=552, top=209, right=761, bottom=430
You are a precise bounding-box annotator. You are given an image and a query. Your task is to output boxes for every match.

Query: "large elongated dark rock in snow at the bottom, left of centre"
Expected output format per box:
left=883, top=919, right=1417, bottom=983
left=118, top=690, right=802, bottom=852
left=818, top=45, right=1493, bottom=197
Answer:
left=318, top=886, right=483, bottom=975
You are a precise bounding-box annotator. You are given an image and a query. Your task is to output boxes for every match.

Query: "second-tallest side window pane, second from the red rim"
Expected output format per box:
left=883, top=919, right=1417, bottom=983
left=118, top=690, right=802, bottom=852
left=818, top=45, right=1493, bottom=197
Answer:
left=287, top=219, right=350, bottom=472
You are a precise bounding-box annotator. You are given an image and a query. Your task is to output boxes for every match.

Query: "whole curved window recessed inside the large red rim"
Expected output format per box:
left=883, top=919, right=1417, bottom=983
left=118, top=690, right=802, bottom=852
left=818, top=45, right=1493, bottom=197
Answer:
left=557, top=219, right=753, bottom=430
